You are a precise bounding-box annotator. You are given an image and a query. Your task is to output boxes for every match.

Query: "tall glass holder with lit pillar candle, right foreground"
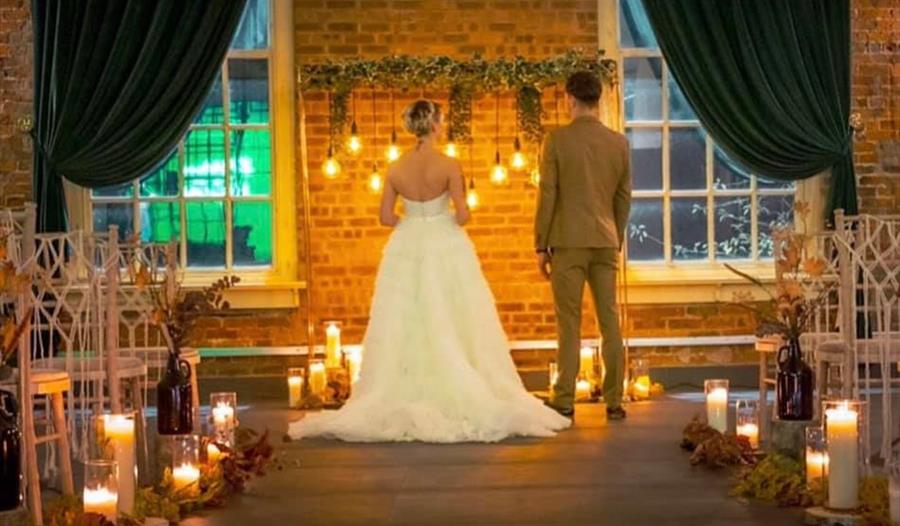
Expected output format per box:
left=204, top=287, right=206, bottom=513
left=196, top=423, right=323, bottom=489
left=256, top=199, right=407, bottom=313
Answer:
left=822, top=400, right=862, bottom=510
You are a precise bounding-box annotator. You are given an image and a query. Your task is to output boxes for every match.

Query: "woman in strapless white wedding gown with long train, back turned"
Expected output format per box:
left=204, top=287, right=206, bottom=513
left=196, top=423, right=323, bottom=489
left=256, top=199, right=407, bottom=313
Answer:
left=289, top=100, right=570, bottom=442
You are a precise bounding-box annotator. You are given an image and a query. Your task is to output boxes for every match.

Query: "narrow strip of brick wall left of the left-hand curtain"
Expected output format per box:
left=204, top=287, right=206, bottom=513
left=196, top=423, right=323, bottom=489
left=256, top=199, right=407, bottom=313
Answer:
left=0, top=0, right=32, bottom=207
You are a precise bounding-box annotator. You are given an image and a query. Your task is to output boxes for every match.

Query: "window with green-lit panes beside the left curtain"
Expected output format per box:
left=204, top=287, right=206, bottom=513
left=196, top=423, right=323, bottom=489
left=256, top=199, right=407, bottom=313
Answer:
left=90, top=0, right=275, bottom=270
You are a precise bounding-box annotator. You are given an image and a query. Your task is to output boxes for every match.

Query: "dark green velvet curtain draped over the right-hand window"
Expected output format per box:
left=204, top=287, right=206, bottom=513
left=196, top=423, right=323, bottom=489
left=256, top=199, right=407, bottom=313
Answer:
left=643, top=0, right=858, bottom=222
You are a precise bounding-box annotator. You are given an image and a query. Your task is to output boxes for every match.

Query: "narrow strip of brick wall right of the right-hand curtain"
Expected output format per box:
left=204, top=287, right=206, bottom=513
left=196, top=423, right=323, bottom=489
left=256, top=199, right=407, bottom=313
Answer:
left=852, top=0, right=900, bottom=214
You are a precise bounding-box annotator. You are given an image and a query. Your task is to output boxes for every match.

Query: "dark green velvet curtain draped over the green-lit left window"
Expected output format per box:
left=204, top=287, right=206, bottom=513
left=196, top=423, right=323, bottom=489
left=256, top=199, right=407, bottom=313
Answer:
left=32, top=0, right=246, bottom=232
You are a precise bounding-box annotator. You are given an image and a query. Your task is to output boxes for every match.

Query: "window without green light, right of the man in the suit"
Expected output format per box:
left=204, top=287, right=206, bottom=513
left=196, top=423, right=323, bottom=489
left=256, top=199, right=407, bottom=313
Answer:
left=619, top=0, right=794, bottom=263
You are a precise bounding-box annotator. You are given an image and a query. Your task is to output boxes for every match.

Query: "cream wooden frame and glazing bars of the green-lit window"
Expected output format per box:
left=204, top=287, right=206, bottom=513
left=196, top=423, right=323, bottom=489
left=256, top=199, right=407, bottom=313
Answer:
left=74, top=0, right=298, bottom=290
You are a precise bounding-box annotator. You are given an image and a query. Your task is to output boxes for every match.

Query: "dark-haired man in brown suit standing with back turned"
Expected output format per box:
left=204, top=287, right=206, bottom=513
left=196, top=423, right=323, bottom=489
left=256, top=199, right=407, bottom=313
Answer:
left=534, top=71, right=631, bottom=420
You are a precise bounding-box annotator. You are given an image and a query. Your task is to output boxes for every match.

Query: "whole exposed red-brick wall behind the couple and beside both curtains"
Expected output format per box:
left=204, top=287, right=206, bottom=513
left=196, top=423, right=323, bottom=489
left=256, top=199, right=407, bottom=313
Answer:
left=0, top=0, right=900, bottom=380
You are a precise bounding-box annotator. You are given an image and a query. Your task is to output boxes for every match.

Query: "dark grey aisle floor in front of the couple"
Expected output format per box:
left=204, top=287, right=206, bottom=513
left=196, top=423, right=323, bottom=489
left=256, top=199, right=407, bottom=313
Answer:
left=185, top=387, right=802, bottom=526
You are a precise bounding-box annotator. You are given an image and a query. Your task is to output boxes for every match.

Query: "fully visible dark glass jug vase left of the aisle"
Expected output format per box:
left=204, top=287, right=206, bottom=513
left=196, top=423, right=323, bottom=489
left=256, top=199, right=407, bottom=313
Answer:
left=156, top=352, right=194, bottom=435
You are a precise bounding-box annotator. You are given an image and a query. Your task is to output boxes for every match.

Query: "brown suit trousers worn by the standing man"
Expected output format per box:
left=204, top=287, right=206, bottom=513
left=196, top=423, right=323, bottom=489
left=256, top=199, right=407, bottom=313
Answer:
left=550, top=248, right=625, bottom=409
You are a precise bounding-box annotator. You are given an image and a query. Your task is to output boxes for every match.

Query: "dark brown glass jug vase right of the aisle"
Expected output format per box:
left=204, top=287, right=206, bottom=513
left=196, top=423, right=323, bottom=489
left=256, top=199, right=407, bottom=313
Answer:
left=775, top=339, right=813, bottom=420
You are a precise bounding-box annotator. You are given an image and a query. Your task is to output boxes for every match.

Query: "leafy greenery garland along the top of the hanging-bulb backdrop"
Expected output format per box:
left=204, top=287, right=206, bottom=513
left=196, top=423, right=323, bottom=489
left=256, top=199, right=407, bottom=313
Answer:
left=298, top=50, right=616, bottom=147
